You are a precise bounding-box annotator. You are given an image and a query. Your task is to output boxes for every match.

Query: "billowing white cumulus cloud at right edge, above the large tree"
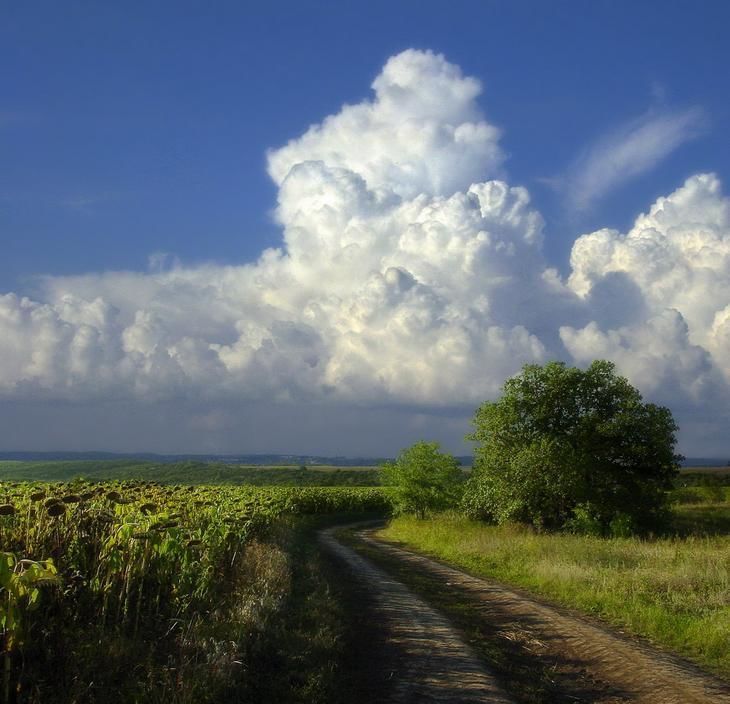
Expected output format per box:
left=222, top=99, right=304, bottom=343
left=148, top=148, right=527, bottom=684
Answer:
left=560, top=174, right=730, bottom=434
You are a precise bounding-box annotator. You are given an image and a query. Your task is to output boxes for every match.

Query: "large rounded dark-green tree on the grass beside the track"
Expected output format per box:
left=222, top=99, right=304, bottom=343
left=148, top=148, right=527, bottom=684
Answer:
left=464, top=361, right=682, bottom=533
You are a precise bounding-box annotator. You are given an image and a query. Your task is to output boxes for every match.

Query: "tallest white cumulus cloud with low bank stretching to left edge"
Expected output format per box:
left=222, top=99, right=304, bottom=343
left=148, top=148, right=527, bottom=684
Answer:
left=2, top=51, right=554, bottom=406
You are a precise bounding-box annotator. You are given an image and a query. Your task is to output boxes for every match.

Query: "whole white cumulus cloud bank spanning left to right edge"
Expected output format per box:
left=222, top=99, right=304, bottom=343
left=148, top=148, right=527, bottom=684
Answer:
left=0, top=50, right=730, bottom=454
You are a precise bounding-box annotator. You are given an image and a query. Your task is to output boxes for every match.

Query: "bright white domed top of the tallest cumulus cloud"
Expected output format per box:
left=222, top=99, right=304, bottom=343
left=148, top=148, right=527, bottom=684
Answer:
left=269, top=49, right=503, bottom=198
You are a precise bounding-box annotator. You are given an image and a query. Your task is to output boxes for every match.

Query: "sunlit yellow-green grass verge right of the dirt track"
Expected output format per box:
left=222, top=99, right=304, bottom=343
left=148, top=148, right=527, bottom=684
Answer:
left=379, top=515, right=730, bottom=677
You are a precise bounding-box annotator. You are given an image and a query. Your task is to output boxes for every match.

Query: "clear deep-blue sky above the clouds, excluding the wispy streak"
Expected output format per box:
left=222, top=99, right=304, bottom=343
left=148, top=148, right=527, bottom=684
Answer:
left=5, top=0, right=730, bottom=290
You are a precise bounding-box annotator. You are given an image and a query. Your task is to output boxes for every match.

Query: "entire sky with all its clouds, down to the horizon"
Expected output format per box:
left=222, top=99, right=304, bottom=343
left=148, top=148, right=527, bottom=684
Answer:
left=0, top=0, right=730, bottom=456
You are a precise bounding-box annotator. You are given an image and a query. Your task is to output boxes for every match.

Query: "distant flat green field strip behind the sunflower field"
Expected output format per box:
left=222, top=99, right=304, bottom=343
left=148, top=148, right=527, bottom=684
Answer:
left=0, top=459, right=379, bottom=486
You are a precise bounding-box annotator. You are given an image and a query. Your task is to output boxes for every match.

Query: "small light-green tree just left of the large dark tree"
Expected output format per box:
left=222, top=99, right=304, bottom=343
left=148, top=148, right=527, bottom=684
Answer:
left=380, top=441, right=464, bottom=518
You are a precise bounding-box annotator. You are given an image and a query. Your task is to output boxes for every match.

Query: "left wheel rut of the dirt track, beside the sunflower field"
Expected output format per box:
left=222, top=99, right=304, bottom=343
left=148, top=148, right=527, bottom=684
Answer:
left=319, top=528, right=512, bottom=704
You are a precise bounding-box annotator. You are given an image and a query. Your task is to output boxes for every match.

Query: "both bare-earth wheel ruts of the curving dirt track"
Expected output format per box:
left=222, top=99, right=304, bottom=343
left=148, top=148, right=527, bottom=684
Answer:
left=321, top=531, right=730, bottom=704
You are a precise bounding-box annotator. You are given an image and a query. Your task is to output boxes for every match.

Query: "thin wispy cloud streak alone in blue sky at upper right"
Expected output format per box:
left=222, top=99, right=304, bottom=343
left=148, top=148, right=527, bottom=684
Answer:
left=561, top=107, right=705, bottom=210
